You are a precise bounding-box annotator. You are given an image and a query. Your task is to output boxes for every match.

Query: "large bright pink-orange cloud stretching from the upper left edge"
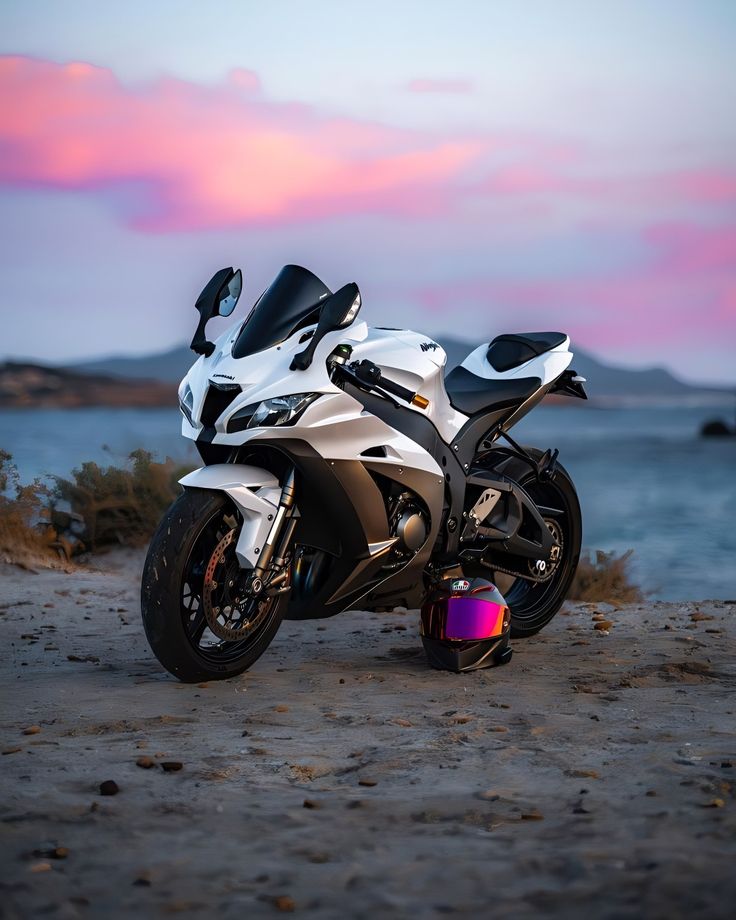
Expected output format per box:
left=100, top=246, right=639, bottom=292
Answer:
left=0, top=57, right=488, bottom=231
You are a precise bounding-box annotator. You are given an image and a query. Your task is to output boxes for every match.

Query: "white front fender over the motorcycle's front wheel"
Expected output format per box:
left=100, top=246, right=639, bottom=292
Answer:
left=179, top=463, right=281, bottom=569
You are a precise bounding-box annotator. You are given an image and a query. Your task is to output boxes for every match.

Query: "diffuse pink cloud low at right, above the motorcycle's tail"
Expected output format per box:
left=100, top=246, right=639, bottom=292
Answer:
left=414, top=224, right=736, bottom=349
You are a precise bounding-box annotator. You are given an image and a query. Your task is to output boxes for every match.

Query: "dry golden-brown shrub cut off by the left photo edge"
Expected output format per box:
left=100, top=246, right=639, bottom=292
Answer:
left=0, top=450, right=60, bottom=568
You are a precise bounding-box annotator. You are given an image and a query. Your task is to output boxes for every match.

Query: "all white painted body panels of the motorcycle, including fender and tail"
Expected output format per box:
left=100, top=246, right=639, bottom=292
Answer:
left=179, top=310, right=572, bottom=568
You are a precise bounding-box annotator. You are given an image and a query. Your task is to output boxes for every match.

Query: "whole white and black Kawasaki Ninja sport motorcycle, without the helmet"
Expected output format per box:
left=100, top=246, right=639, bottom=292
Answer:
left=142, top=265, right=586, bottom=681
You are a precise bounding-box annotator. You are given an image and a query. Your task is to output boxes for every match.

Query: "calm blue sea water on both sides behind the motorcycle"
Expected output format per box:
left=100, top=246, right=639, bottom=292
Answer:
left=0, top=403, right=736, bottom=600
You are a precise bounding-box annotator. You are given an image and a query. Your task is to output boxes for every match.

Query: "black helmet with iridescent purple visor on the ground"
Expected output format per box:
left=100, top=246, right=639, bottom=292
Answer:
left=422, top=578, right=511, bottom=673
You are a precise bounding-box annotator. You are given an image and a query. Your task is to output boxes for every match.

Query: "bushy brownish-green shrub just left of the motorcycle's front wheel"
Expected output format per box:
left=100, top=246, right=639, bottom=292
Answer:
left=55, top=450, right=186, bottom=552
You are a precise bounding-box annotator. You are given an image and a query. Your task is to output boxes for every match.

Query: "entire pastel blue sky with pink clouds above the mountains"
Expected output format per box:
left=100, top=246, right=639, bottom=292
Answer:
left=0, top=0, right=736, bottom=383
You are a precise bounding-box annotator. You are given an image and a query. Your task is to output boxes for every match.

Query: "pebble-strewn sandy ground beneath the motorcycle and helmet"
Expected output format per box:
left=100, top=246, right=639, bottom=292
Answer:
left=0, top=554, right=736, bottom=918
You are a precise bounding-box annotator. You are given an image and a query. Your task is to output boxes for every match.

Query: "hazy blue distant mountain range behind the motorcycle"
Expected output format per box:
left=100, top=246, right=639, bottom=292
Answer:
left=71, top=336, right=736, bottom=399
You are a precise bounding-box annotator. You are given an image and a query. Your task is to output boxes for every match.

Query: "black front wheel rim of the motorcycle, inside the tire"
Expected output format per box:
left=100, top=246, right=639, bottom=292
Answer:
left=181, top=506, right=277, bottom=665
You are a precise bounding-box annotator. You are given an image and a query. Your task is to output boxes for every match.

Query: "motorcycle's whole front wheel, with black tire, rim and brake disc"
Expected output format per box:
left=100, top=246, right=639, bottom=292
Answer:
left=141, top=489, right=288, bottom=683
